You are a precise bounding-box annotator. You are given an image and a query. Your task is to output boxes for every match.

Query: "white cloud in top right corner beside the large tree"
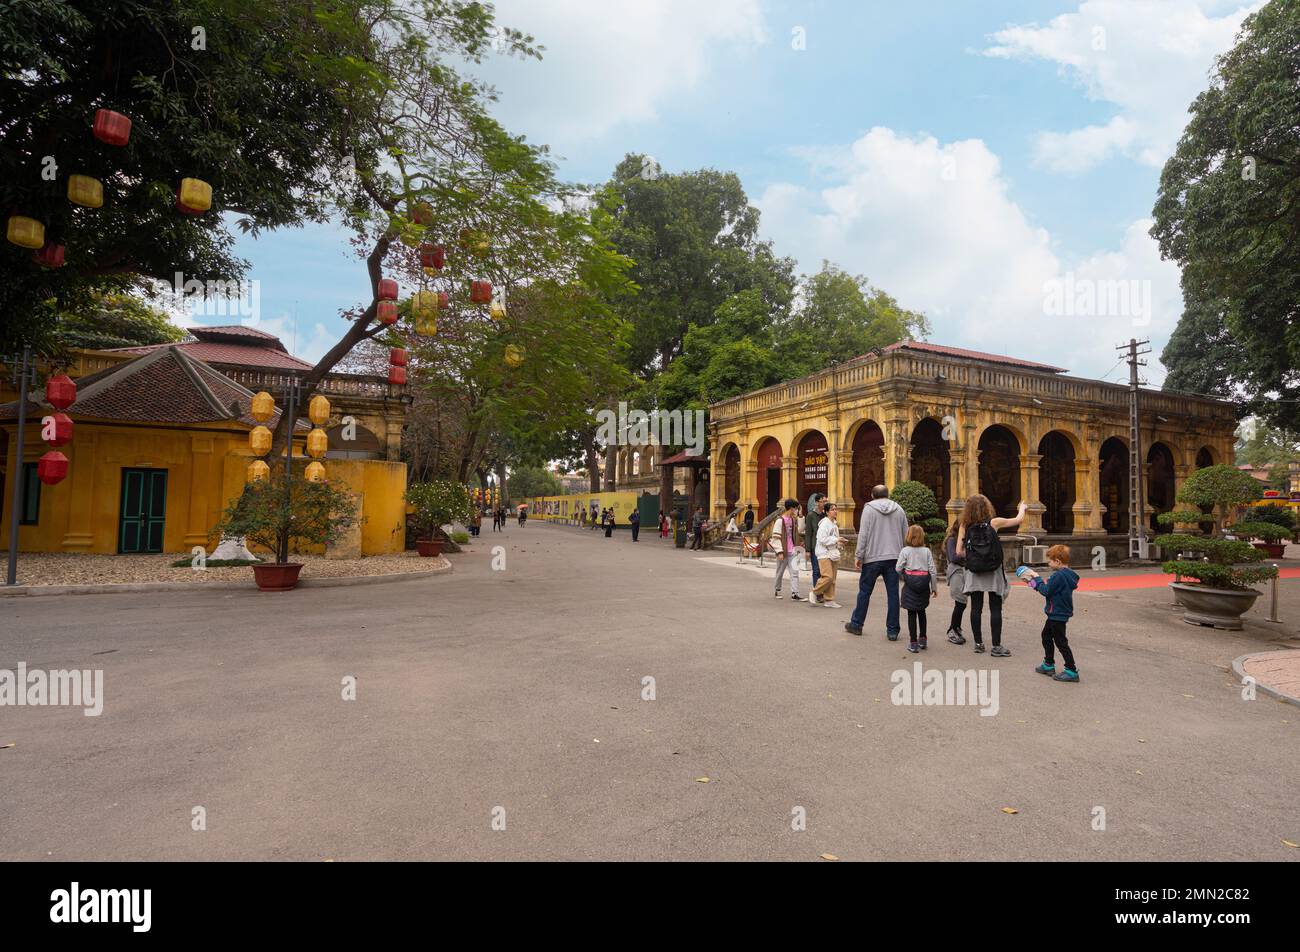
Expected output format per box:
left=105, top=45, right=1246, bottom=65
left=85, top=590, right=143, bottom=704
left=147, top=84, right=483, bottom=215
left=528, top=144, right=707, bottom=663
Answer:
left=984, top=0, right=1262, bottom=173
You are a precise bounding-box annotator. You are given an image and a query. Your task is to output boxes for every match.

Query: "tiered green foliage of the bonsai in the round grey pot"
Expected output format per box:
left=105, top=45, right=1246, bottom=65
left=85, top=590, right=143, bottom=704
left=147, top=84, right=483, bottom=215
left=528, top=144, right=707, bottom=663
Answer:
left=1156, top=464, right=1277, bottom=592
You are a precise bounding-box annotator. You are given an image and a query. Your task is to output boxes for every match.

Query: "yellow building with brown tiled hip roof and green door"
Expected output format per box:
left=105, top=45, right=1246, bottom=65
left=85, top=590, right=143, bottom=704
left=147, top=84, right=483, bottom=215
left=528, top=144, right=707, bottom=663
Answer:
left=0, top=328, right=407, bottom=557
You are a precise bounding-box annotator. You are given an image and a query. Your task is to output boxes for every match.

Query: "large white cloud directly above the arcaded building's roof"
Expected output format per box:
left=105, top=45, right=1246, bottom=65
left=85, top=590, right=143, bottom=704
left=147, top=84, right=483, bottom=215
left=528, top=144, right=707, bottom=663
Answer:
left=758, top=127, right=1182, bottom=376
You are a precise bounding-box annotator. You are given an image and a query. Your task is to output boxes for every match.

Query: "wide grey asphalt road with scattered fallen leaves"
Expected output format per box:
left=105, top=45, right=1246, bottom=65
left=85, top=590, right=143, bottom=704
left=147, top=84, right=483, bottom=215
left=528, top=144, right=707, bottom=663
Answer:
left=0, top=523, right=1300, bottom=861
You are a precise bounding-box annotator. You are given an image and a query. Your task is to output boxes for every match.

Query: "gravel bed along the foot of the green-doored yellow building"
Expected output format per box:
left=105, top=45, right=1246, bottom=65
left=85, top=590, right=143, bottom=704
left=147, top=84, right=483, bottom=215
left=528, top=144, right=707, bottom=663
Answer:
left=0, top=551, right=446, bottom=585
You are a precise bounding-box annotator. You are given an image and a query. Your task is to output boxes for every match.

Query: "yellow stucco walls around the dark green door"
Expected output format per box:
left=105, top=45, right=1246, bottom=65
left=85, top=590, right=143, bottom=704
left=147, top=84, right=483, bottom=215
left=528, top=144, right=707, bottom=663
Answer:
left=0, top=420, right=406, bottom=555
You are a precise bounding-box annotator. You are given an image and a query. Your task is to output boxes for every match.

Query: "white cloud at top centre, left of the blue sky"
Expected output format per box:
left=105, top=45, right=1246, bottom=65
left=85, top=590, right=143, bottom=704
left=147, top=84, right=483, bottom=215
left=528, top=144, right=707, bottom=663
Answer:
left=481, top=0, right=767, bottom=146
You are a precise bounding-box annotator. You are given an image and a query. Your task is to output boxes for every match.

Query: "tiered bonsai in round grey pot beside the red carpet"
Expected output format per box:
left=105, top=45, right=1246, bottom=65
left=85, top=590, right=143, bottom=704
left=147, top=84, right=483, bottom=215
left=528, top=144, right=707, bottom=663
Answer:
left=1156, top=464, right=1277, bottom=629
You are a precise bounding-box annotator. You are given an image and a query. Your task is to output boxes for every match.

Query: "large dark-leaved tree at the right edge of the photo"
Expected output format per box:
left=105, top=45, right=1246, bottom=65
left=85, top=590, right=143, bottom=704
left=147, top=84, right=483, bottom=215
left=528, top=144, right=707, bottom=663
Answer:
left=1152, top=0, right=1300, bottom=429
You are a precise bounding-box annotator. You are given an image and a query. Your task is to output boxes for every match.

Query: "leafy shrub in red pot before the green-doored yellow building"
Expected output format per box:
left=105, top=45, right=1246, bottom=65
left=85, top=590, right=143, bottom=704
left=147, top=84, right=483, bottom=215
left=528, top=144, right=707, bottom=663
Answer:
left=216, top=469, right=356, bottom=592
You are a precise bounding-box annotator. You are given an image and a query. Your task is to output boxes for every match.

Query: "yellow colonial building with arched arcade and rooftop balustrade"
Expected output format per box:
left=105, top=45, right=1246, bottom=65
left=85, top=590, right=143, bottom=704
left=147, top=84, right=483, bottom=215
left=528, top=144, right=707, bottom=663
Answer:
left=709, top=341, right=1236, bottom=538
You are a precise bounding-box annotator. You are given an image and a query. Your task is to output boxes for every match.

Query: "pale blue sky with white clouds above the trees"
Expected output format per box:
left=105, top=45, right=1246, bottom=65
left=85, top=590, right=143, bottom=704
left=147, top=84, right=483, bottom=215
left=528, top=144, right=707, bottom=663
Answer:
left=213, top=0, right=1258, bottom=382
